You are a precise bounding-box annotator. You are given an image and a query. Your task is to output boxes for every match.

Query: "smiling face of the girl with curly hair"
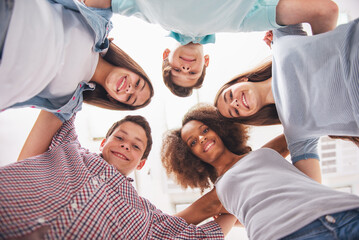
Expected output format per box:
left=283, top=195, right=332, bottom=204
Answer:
left=181, top=120, right=225, bottom=165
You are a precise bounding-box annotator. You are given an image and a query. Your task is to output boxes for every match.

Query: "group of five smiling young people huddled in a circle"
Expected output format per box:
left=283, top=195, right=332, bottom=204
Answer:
left=0, top=0, right=359, bottom=239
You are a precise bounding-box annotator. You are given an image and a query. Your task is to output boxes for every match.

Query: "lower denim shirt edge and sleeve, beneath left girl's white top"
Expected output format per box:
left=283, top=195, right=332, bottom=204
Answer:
left=5, top=82, right=96, bottom=122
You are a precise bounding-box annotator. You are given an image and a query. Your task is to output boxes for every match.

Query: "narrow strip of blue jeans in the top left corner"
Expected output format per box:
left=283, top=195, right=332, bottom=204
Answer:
left=0, top=0, right=14, bottom=59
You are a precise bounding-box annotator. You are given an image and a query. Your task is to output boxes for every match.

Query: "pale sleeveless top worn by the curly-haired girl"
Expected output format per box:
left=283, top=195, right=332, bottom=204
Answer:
left=215, top=148, right=359, bottom=240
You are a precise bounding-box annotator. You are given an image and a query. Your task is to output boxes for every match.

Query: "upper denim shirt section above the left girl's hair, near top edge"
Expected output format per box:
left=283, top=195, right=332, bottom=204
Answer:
left=48, top=0, right=113, bottom=52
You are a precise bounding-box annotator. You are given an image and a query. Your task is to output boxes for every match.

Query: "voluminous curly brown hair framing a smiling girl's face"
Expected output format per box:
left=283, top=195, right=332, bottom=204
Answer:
left=161, top=103, right=251, bottom=191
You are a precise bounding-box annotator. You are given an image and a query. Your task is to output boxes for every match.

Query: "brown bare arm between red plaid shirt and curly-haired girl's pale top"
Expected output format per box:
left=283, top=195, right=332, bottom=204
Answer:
left=175, top=188, right=222, bottom=224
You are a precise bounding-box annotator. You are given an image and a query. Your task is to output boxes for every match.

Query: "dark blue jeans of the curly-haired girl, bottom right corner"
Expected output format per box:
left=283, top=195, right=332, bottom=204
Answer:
left=282, top=208, right=359, bottom=240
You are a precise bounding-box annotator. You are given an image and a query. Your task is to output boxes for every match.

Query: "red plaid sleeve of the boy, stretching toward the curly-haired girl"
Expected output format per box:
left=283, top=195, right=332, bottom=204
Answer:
left=141, top=198, right=224, bottom=240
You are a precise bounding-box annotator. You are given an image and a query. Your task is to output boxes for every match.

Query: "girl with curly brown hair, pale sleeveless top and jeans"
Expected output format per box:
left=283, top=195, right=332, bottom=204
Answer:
left=162, top=103, right=359, bottom=240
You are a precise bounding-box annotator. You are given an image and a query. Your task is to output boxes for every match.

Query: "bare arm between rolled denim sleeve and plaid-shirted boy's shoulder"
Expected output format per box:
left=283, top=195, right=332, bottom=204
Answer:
left=18, top=110, right=62, bottom=161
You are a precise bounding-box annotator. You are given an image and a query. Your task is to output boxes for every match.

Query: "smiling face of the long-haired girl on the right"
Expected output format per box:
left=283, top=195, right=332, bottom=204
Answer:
left=217, top=78, right=265, bottom=118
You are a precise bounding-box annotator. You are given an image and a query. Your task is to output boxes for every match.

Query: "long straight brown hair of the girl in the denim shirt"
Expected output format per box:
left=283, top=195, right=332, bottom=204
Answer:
left=83, top=42, right=154, bottom=110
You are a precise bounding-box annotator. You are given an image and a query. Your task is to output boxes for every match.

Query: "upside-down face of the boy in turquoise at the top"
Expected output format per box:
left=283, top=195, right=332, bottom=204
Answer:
left=163, top=43, right=209, bottom=87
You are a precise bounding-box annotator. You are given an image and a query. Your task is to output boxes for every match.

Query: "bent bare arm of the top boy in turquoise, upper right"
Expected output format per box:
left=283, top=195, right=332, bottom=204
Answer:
left=276, top=0, right=338, bottom=34
